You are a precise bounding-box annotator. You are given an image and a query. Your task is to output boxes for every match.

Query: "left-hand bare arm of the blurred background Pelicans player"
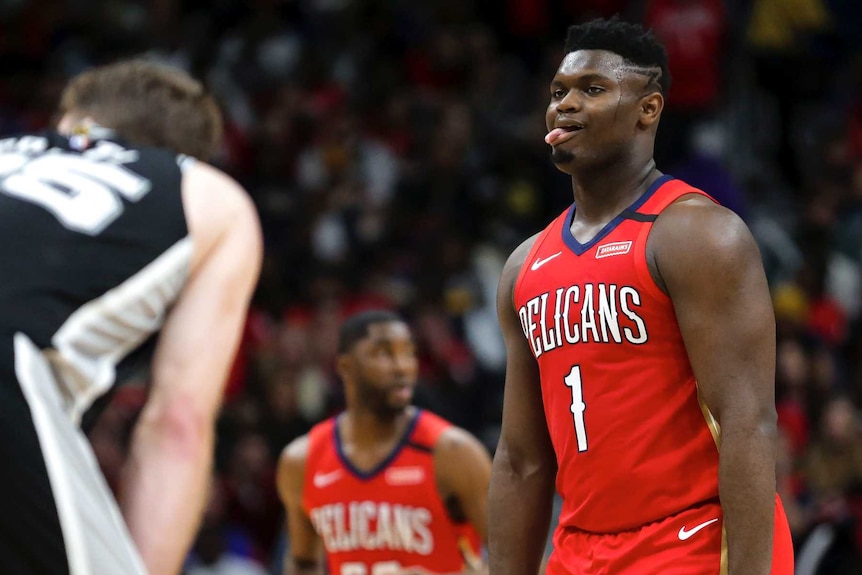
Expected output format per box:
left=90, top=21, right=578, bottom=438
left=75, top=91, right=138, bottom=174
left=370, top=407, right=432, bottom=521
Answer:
left=276, top=435, right=324, bottom=575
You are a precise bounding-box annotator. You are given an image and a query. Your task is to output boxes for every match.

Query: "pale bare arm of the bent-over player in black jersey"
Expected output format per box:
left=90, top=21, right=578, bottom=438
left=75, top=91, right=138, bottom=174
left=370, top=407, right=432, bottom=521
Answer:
left=120, top=164, right=261, bottom=575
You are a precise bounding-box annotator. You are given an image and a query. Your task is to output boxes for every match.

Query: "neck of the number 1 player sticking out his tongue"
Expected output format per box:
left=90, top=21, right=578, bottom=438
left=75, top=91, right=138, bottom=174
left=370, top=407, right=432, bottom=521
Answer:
left=572, top=158, right=661, bottom=223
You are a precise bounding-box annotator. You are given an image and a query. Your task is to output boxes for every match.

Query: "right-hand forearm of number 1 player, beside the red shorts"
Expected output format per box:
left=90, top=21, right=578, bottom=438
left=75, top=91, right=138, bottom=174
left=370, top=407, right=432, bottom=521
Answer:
left=719, top=422, right=775, bottom=575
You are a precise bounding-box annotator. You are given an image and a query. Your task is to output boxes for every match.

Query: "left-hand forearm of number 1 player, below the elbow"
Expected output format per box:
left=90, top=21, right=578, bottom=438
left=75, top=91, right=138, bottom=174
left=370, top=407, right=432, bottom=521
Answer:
left=488, top=445, right=555, bottom=575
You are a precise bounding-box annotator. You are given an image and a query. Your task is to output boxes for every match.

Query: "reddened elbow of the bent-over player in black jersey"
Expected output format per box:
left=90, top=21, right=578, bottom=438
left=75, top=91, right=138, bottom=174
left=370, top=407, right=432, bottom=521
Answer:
left=139, top=397, right=214, bottom=458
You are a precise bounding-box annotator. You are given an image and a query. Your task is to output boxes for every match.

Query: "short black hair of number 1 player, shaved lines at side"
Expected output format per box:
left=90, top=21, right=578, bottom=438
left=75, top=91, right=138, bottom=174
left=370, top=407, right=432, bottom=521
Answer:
left=565, top=16, right=670, bottom=95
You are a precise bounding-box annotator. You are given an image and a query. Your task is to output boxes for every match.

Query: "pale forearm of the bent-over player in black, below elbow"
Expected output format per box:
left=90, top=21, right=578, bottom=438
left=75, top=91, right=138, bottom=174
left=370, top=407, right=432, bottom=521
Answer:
left=121, top=402, right=215, bottom=575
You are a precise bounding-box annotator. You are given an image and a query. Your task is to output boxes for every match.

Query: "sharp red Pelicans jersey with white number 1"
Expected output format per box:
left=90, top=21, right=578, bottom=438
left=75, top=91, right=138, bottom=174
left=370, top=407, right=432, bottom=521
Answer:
left=514, top=176, right=718, bottom=533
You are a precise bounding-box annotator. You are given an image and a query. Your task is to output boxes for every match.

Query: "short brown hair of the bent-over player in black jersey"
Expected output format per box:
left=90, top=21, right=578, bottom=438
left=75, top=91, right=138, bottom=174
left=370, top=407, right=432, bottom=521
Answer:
left=58, top=60, right=222, bottom=160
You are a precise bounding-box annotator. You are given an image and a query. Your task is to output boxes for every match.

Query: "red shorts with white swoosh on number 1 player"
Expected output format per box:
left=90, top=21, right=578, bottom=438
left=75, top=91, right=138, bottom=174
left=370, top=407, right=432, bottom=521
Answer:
left=546, top=496, right=793, bottom=575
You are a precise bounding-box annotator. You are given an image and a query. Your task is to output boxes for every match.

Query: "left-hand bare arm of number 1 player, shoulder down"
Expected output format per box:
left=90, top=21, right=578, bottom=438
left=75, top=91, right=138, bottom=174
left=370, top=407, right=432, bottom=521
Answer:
left=488, top=238, right=557, bottom=575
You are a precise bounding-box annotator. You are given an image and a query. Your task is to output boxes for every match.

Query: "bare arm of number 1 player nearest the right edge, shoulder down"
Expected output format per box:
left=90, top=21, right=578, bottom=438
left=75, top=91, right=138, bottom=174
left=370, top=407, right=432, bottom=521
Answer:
left=648, top=198, right=776, bottom=575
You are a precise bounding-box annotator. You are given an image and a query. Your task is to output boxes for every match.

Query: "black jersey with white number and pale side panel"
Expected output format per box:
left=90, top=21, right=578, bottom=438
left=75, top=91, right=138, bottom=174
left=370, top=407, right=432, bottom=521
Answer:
left=0, top=133, right=192, bottom=421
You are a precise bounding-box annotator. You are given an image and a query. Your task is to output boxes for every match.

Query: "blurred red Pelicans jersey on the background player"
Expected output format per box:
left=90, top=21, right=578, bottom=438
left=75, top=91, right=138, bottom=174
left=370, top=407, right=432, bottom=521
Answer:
left=302, top=410, right=480, bottom=575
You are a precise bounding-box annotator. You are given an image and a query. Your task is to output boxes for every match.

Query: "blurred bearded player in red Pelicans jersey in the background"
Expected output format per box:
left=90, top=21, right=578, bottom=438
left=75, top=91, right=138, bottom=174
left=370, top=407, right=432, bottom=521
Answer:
left=277, top=310, right=491, bottom=575
